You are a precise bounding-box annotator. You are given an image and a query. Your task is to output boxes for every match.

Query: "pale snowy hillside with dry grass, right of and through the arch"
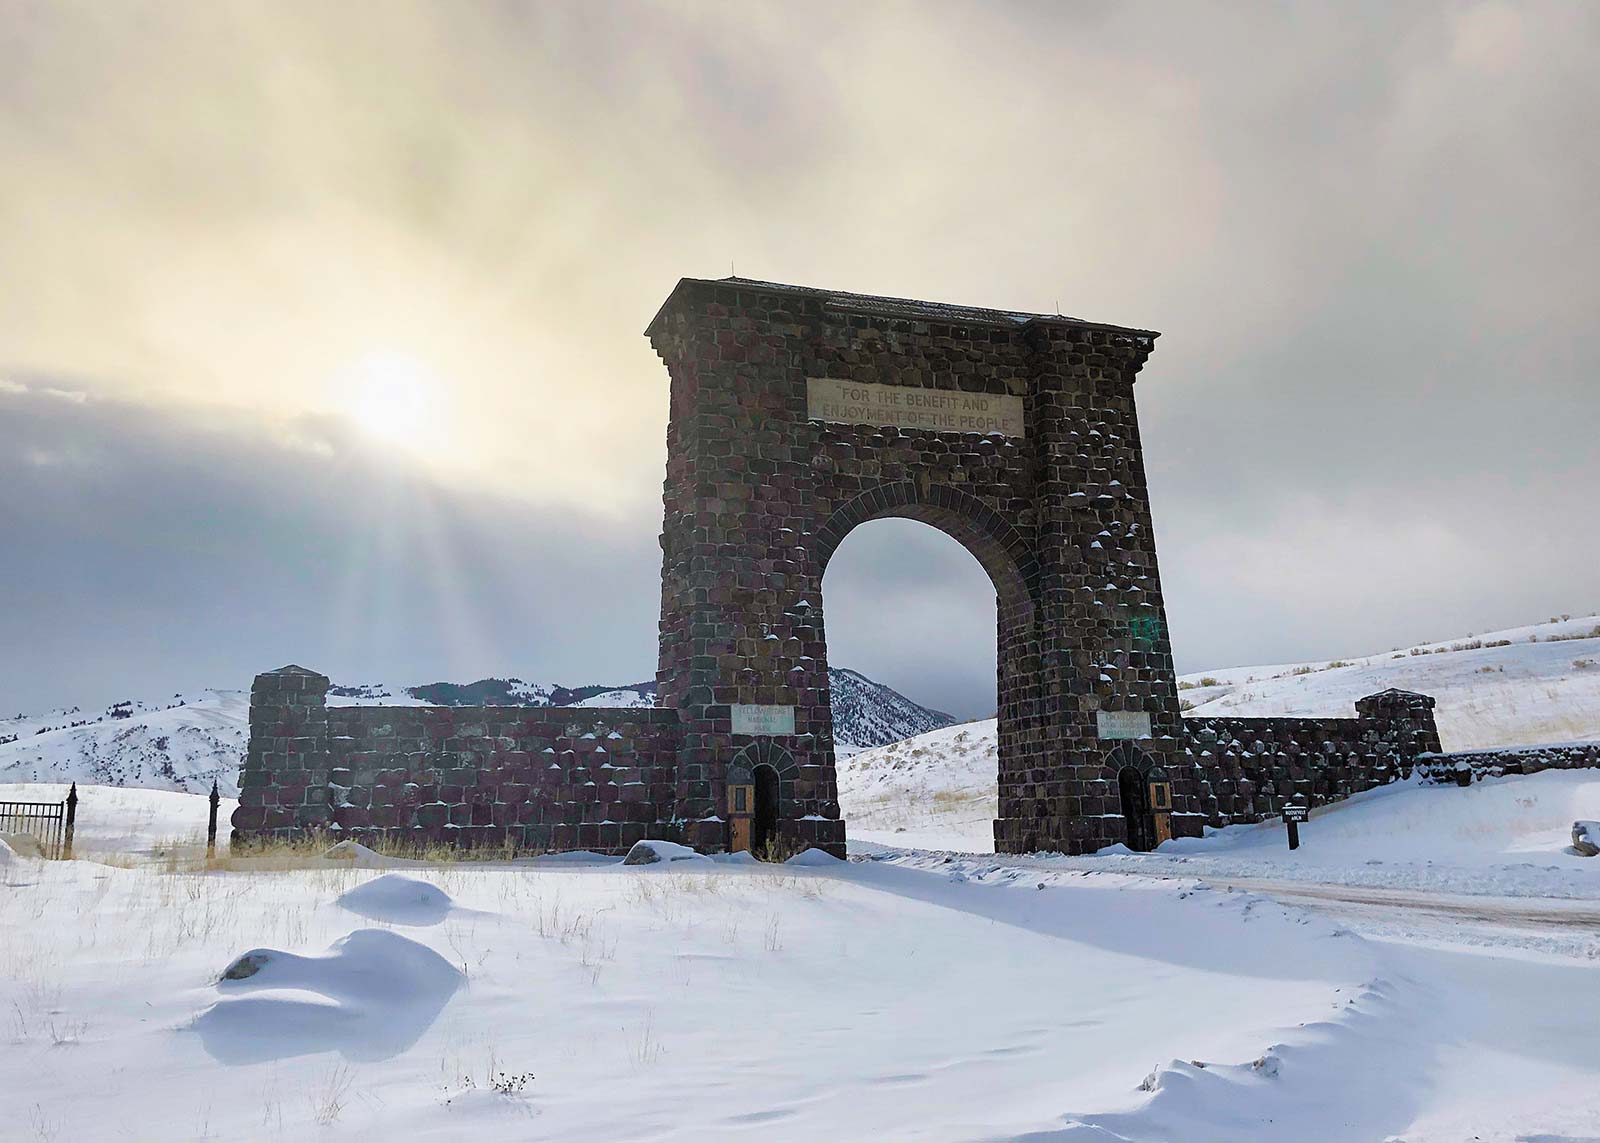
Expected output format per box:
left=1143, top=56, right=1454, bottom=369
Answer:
left=838, top=615, right=1600, bottom=852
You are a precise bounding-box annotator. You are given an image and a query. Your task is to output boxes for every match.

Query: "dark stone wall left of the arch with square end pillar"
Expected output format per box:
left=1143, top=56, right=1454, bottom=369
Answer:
left=234, top=668, right=682, bottom=853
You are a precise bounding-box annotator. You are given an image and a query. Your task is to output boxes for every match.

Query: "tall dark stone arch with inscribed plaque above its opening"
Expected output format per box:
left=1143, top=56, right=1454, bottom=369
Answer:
left=646, top=279, right=1194, bottom=856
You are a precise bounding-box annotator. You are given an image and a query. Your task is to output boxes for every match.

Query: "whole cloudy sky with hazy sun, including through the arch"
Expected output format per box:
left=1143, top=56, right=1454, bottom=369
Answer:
left=0, top=0, right=1600, bottom=714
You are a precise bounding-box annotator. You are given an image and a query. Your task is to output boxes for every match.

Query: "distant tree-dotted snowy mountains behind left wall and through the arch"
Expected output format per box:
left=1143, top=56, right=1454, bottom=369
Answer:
left=0, top=668, right=954, bottom=796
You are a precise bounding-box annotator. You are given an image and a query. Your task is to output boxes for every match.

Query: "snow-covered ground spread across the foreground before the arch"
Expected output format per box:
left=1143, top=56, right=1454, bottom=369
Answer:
left=0, top=775, right=1600, bottom=1143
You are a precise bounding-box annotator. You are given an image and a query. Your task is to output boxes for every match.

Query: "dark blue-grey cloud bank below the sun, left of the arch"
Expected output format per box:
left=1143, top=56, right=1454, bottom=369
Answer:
left=0, top=387, right=659, bottom=709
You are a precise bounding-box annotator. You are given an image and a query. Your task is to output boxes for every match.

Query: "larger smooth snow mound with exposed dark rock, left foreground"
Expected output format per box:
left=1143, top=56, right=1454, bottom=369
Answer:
left=194, top=928, right=464, bottom=1065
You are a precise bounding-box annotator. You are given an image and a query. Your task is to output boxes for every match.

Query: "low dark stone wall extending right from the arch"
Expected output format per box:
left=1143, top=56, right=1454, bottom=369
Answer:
left=1182, top=690, right=1438, bottom=826
